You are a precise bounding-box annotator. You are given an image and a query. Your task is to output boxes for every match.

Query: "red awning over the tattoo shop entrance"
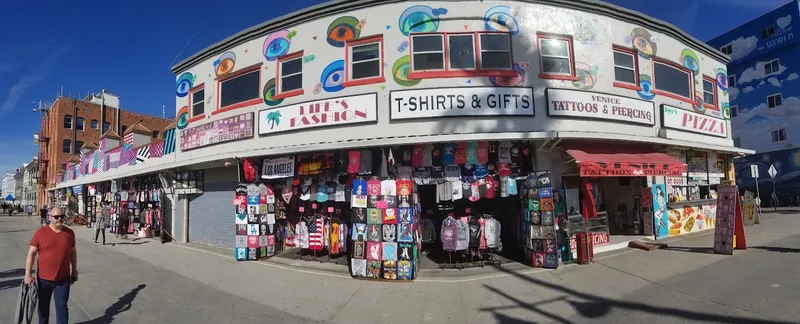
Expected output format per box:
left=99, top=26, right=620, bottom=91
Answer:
left=566, top=144, right=688, bottom=177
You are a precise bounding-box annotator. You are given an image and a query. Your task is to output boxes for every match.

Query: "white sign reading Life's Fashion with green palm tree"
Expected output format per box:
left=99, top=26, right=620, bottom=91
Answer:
left=258, top=93, right=378, bottom=135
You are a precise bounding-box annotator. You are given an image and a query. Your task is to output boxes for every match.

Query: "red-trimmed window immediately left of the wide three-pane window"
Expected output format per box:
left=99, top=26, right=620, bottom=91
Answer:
left=344, top=35, right=386, bottom=87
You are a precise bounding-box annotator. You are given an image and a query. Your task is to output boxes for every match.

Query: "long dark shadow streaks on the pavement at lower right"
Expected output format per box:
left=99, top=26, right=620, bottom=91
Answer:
left=478, top=267, right=789, bottom=324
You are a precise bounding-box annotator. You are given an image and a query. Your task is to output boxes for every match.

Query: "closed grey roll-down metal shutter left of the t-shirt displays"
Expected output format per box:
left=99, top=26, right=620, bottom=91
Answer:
left=189, top=167, right=238, bottom=249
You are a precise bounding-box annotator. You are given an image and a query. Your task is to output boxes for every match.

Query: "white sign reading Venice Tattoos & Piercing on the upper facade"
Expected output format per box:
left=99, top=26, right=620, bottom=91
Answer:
left=547, top=89, right=656, bottom=126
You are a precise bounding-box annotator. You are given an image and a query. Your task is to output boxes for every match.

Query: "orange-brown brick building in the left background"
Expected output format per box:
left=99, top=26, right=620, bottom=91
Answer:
left=38, top=90, right=172, bottom=205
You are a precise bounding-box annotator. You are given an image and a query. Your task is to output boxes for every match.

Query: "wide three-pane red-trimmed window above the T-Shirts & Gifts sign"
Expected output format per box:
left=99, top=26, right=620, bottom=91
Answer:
left=408, top=32, right=517, bottom=79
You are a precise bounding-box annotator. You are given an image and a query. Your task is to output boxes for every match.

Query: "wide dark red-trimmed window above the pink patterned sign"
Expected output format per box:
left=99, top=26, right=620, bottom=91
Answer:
left=214, top=63, right=263, bottom=115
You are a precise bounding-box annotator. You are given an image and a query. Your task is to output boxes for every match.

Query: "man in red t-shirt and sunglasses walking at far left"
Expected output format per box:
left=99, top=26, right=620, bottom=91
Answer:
left=25, top=207, right=78, bottom=324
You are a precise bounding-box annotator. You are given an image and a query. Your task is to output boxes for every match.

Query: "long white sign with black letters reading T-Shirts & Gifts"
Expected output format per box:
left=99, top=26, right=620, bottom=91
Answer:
left=389, top=87, right=534, bottom=120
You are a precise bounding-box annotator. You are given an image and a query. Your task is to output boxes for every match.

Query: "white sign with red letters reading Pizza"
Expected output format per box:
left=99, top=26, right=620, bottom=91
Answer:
left=661, top=105, right=728, bottom=137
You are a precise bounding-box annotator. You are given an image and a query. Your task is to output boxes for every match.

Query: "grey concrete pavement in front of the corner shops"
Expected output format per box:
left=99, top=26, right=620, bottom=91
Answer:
left=0, top=210, right=800, bottom=323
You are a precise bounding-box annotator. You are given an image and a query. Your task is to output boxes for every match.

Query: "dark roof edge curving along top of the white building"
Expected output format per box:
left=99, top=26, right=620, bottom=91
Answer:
left=172, top=0, right=729, bottom=74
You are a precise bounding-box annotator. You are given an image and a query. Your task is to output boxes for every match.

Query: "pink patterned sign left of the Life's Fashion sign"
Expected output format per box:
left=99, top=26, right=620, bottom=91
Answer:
left=180, top=113, right=253, bottom=151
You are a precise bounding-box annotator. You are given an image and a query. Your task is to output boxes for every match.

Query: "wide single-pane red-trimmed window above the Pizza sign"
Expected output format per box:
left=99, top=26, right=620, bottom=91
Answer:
left=652, top=57, right=695, bottom=104
